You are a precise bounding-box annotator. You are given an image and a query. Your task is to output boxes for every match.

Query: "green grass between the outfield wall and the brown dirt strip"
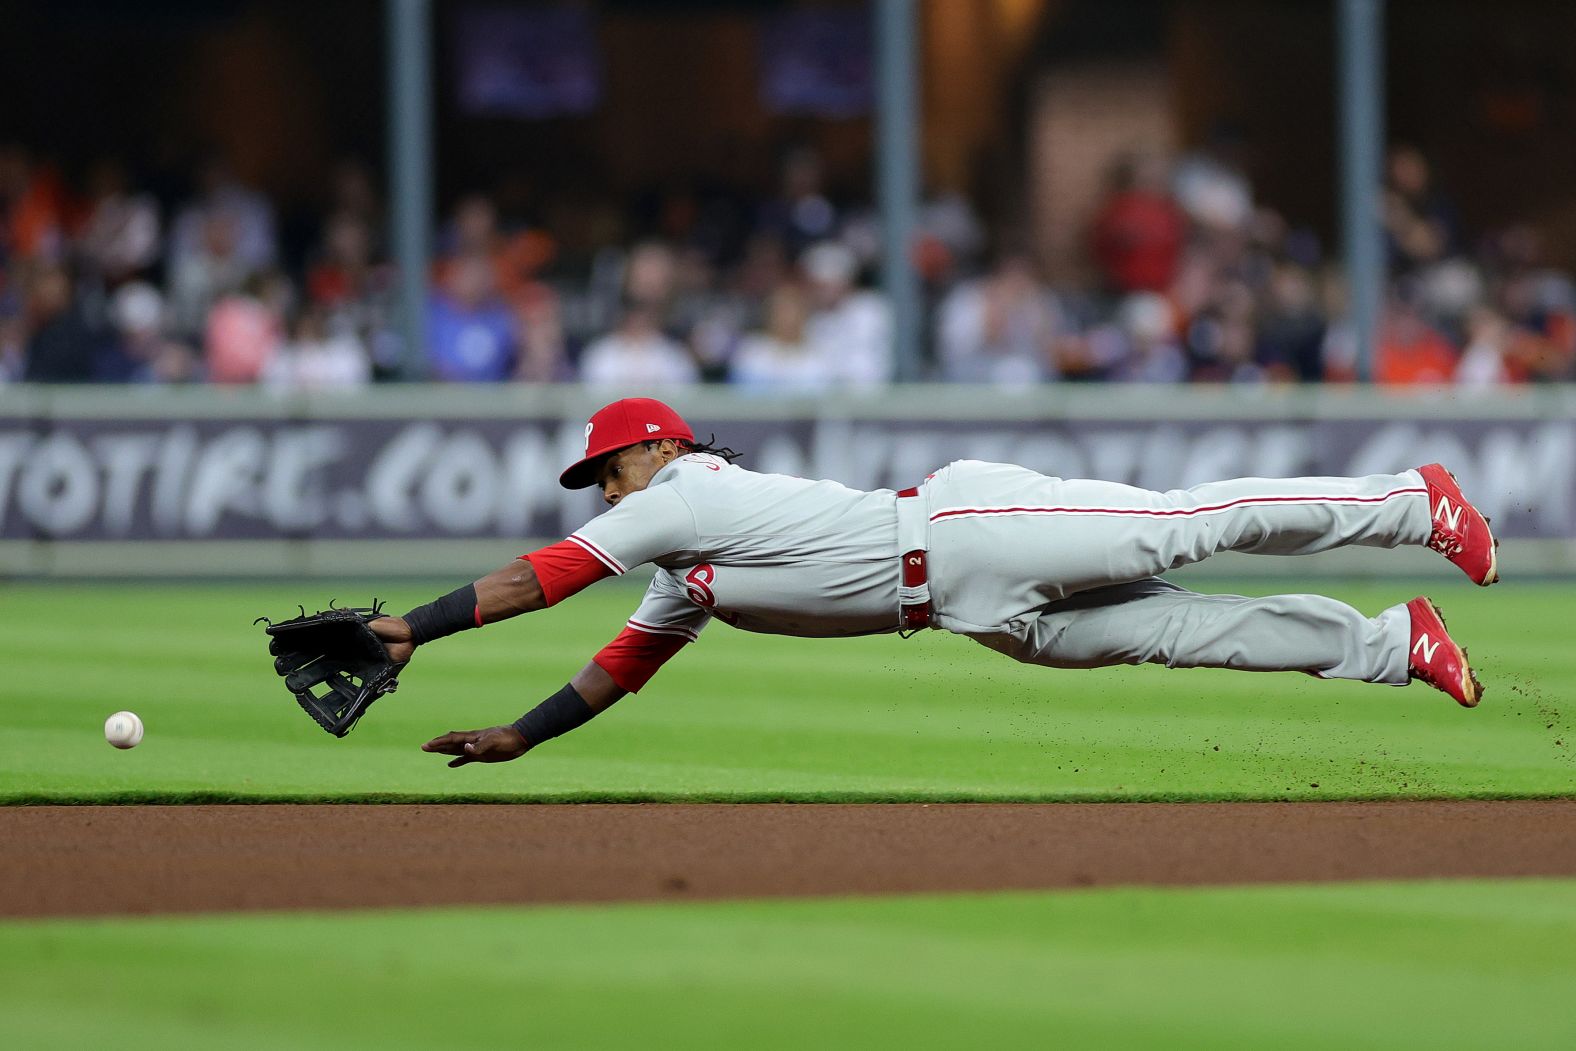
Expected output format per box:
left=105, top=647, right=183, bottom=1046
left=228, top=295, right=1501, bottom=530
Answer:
left=0, top=581, right=1576, bottom=802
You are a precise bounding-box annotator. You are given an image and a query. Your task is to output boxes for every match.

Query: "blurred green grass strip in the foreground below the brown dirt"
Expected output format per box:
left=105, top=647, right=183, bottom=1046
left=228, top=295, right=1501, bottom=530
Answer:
left=0, top=881, right=1576, bottom=1051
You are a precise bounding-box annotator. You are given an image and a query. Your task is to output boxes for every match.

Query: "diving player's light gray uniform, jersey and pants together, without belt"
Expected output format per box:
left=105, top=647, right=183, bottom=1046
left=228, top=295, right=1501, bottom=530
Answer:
left=569, top=454, right=1429, bottom=682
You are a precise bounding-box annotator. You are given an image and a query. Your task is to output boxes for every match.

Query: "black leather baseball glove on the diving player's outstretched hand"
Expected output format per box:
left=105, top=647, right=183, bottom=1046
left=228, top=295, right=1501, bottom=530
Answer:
left=258, top=602, right=405, bottom=737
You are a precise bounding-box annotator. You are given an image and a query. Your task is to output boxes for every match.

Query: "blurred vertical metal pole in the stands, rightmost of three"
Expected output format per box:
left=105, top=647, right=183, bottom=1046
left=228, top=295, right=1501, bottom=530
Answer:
left=1336, top=0, right=1388, bottom=383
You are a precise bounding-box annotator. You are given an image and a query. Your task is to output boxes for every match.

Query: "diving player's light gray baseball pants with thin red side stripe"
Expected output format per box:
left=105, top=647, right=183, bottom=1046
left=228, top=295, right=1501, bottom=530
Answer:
left=922, top=460, right=1431, bottom=685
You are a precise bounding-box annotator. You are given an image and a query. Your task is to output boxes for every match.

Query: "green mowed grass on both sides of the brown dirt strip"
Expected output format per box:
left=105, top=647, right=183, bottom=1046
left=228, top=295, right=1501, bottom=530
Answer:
left=0, top=581, right=1576, bottom=1051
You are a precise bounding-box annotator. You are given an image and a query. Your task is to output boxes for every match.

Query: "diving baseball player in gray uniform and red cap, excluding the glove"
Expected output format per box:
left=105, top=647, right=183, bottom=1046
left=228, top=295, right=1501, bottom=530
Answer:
left=370, top=399, right=1499, bottom=766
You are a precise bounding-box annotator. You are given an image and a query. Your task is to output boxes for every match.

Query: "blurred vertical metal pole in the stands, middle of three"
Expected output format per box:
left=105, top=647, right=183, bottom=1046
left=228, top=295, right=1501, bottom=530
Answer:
left=875, top=0, right=924, bottom=380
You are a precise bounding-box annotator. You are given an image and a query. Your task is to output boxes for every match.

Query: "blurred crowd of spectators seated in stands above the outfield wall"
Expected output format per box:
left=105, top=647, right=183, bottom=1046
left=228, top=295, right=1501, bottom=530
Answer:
left=0, top=143, right=1576, bottom=394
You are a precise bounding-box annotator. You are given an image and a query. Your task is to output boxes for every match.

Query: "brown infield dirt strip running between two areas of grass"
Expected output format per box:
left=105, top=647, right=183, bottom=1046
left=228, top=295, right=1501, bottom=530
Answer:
left=9, top=800, right=1576, bottom=917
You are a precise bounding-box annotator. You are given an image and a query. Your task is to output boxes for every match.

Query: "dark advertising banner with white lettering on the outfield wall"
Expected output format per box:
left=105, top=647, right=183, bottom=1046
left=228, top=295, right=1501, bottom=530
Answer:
left=0, top=413, right=1576, bottom=542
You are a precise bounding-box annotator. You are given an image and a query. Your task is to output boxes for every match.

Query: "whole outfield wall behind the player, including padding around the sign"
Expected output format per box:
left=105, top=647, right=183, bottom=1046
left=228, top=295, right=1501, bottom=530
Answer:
left=0, top=386, right=1576, bottom=577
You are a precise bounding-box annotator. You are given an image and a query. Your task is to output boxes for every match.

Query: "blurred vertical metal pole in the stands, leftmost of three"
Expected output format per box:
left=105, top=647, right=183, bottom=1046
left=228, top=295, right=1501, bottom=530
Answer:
left=385, top=0, right=432, bottom=380
